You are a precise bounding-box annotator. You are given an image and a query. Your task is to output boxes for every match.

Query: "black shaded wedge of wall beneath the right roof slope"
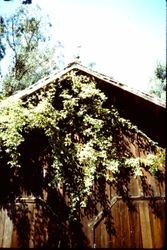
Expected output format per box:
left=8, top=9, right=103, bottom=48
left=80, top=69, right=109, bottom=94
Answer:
left=94, top=76, right=166, bottom=147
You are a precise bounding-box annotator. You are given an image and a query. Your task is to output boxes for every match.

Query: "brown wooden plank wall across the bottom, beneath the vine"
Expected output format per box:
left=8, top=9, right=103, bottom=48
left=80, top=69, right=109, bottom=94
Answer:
left=0, top=129, right=165, bottom=248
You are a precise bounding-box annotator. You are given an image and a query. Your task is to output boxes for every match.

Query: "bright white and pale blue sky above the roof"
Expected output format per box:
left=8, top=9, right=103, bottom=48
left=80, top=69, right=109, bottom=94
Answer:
left=0, top=0, right=166, bottom=91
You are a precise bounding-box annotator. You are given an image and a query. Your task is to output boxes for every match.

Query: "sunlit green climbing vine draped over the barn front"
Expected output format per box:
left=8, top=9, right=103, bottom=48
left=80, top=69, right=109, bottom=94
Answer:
left=0, top=73, right=164, bottom=220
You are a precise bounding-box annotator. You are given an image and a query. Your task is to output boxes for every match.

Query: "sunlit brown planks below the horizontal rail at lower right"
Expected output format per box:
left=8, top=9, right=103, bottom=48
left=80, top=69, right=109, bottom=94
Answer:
left=90, top=199, right=165, bottom=248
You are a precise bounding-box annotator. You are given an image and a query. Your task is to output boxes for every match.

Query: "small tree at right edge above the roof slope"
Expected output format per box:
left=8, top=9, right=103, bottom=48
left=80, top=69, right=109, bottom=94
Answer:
left=149, top=63, right=166, bottom=100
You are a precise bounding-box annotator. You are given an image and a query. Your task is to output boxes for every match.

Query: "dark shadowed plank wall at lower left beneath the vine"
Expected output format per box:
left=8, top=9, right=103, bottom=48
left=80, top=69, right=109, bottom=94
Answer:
left=0, top=131, right=88, bottom=248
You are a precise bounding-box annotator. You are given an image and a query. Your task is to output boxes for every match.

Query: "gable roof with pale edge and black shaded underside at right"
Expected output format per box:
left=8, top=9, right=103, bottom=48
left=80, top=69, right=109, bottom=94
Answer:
left=4, top=62, right=166, bottom=147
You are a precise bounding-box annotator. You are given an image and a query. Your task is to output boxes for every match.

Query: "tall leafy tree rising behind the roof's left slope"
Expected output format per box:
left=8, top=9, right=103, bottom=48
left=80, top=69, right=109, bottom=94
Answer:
left=1, top=5, right=64, bottom=96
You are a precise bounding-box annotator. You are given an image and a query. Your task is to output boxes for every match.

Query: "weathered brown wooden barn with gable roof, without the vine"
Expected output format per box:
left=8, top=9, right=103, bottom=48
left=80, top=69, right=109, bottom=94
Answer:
left=0, top=63, right=166, bottom=248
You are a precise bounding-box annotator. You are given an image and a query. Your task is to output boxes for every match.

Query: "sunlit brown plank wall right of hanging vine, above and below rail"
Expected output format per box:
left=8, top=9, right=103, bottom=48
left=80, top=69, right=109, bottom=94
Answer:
left=85, top=176, right=165, bottom=249
